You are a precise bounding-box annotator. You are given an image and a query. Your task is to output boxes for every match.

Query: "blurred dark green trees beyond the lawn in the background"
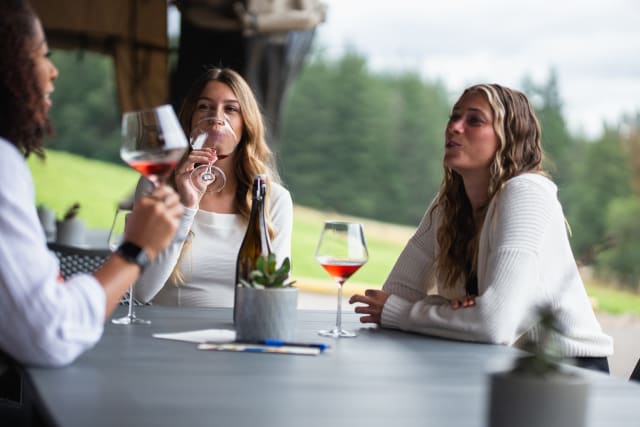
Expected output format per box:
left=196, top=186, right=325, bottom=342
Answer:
left=49, top=51, right=640, bottom=290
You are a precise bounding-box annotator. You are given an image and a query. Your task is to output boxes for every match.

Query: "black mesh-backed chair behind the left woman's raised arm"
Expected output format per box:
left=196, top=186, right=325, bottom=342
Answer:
left=47, top=243, right=142, bottom=305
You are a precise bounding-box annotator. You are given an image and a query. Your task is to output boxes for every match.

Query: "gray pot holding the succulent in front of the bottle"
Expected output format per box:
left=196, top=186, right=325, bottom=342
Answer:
left=236, top=286, right=298, bottom=341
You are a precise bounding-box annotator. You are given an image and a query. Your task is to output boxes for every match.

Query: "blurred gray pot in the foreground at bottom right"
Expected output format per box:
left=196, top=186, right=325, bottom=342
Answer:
left=488, top=372, right=589, bottom=427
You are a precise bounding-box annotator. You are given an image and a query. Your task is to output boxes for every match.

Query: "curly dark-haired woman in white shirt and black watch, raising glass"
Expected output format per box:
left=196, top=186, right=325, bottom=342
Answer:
left=0, top=0, right=182, bottom=372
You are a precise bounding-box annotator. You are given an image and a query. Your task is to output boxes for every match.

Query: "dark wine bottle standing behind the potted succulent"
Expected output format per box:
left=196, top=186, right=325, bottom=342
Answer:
left=233, top=174, right=271, bottom=322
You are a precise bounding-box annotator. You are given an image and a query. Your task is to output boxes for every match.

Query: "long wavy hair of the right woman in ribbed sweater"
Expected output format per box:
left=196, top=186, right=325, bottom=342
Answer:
left=430, top=84, right=545, bottom=288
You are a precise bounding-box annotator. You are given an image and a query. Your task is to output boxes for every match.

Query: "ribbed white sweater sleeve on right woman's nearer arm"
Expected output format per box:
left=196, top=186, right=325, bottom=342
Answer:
left=381, top=181, right=552, bottom=345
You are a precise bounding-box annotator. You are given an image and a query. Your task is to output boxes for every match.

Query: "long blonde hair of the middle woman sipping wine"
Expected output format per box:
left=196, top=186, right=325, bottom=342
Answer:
left=170, top=67, right=280, bottom=284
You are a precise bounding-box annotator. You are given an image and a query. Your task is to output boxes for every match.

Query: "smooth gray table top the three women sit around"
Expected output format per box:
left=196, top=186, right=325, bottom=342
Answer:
left=28, top=307, right=640, bottom=427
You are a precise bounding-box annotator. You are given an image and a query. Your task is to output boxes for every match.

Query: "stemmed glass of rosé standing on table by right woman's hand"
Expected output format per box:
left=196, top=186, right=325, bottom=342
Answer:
left=316, top=221, right=369, bottom=338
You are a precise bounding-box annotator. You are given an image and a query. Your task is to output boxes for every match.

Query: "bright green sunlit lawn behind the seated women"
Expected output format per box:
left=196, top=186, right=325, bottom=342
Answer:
left=29, top=151, right=640, bottom=315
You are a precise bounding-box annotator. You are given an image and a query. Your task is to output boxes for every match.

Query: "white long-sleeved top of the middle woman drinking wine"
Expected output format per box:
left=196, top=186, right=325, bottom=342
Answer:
left=134, top=184, right=293, bottom=307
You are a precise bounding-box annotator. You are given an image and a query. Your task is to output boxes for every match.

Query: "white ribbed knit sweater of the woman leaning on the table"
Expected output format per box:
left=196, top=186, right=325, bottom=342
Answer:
left=381, top=174, right=613, bottom=357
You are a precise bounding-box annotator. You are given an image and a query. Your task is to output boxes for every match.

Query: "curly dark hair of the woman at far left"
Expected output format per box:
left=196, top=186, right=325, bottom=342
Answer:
left=0, top=0, right=51, bottom=157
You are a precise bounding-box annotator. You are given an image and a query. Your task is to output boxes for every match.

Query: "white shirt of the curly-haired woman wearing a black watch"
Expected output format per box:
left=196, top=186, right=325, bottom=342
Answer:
left=0, top=138, right=106, bottom=366
